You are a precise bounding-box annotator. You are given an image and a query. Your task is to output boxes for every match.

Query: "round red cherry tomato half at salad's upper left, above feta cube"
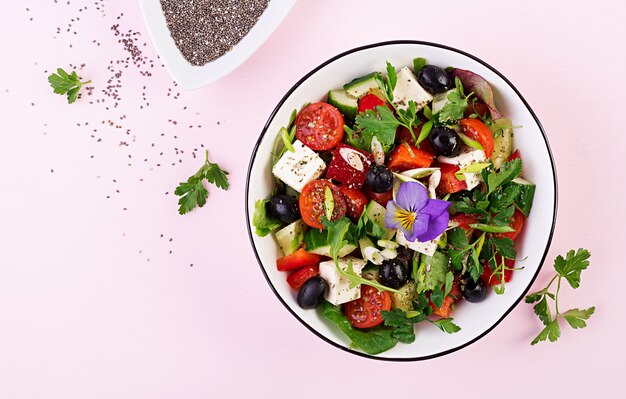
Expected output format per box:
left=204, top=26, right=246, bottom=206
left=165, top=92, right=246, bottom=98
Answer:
left=296, top=102, right=344, bottom=151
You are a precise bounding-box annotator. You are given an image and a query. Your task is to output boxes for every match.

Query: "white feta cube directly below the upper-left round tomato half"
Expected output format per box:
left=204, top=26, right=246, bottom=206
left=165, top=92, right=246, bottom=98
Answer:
left=272, top=140, right=326, bottom=192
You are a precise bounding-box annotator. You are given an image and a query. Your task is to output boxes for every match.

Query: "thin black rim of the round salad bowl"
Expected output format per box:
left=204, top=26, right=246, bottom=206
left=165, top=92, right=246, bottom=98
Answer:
left=244, top=40, right=558, bottom=362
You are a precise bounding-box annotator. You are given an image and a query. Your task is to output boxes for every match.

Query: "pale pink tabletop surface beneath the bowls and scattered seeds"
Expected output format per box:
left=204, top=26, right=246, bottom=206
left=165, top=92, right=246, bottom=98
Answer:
left=0, top=0, right=626, bottom=398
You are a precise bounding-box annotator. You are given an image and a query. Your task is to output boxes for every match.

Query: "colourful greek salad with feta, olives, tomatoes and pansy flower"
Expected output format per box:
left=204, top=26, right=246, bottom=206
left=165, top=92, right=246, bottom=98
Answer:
left=252, top=58, right=535, bottom=354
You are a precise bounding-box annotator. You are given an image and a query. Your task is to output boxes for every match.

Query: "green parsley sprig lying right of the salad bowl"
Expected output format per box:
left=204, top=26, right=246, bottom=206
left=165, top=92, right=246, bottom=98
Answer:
left=526, top=248, right=596, bottom=345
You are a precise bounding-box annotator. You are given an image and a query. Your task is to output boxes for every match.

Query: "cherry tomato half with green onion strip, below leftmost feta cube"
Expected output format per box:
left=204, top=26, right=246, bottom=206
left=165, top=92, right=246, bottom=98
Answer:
left=298, top=180, right=347, bottom=229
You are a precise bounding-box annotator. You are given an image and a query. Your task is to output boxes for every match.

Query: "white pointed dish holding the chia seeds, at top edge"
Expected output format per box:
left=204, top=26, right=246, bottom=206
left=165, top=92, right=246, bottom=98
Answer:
left=140, top=0, right=296, bottom=89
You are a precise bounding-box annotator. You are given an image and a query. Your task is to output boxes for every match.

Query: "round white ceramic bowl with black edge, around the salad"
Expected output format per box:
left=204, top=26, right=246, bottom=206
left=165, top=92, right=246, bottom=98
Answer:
left=246, top=41, right=557, bottom=361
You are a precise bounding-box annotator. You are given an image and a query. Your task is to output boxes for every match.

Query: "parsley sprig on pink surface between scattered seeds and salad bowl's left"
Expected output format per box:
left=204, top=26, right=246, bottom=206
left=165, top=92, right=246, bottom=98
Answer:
left=174, top=150, right=229, bottom=215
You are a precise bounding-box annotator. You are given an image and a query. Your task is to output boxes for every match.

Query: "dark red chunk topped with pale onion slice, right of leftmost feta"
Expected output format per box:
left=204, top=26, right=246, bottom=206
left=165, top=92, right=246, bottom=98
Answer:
left=326, top=143, right=374, bottom=188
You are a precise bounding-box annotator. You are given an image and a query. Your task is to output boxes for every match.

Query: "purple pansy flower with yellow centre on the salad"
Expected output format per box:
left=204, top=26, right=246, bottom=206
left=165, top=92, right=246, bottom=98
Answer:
left=385, top=182, right=452, bottom=242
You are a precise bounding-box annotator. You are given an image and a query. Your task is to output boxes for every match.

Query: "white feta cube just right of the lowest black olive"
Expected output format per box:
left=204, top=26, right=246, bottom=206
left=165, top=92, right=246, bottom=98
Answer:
left=320, top=256, right=366, bottom=305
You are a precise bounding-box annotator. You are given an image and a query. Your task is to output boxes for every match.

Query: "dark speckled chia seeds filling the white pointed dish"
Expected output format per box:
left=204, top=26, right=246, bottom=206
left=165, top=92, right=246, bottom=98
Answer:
left=161, top=0, right=269, bottom=66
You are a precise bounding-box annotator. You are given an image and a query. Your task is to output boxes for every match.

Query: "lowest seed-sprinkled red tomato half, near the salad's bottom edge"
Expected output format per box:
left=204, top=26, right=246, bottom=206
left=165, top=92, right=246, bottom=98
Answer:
left=344, top=284, right=391, bottom=328
